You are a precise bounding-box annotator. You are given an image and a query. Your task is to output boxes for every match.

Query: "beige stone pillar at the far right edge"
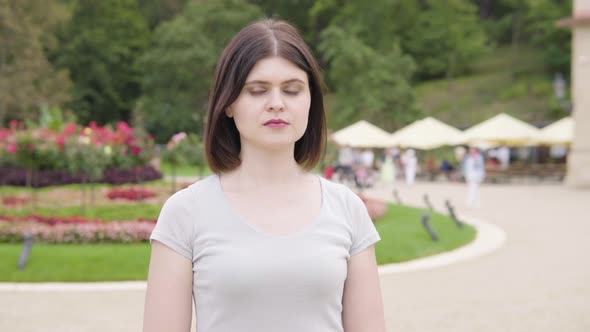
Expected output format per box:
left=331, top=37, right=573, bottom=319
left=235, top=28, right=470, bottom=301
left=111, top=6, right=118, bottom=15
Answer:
left=557, top=0, right=590, bottom=188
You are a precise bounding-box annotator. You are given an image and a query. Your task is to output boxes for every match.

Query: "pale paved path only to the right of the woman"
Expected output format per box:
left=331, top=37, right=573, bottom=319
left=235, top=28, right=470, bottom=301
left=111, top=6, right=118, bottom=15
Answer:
left=367, top=183, right=590, bottom=332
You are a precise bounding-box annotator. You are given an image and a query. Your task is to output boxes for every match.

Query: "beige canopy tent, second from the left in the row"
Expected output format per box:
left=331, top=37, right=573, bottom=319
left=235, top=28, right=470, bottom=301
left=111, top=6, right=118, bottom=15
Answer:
left=390, top=117, right=461, bottom=150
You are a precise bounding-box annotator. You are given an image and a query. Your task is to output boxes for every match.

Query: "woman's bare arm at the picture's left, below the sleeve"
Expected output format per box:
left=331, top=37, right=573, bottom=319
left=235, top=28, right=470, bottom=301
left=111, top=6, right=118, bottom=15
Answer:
left=143, top=240, right=193, bottom=332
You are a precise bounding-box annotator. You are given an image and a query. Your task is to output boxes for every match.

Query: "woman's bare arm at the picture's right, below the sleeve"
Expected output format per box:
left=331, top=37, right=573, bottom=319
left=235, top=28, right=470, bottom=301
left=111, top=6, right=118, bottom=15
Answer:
left=342, top=246, right=385, bottom=332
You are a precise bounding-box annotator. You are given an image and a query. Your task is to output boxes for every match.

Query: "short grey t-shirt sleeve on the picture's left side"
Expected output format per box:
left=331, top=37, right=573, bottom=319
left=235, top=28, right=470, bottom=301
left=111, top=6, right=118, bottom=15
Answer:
left=150, top=188, right=194, bottom=261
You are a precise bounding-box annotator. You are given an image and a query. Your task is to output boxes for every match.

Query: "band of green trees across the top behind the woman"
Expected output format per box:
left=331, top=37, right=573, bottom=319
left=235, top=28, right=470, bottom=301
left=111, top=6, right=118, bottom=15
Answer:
left=0, top=0, right=572, bottom=134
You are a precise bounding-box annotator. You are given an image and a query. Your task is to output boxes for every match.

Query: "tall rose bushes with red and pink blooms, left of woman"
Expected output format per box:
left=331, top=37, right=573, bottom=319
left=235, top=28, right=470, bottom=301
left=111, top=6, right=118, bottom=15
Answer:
left=0, top=121, right=162, bottom=187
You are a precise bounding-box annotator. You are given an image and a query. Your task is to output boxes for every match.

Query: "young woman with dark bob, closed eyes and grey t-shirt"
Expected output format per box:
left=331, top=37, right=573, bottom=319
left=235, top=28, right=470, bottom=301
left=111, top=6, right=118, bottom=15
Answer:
left=144, top=20, right=385, bottom=332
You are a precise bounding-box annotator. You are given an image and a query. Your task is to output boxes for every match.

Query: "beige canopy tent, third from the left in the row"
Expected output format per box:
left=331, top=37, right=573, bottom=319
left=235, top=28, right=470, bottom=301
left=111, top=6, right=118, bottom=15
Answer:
left=455, top=113, right=540, bottom=146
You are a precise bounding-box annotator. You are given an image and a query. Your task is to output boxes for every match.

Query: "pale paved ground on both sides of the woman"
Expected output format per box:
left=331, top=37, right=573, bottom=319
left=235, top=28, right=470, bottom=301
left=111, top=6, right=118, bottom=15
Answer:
left=0, top=183, right=590, bottom=332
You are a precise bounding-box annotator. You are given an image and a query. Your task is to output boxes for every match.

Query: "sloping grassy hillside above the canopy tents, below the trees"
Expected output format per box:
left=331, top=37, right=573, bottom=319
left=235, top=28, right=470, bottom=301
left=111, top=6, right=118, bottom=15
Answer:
left=415, top=47, right=567, bottom=129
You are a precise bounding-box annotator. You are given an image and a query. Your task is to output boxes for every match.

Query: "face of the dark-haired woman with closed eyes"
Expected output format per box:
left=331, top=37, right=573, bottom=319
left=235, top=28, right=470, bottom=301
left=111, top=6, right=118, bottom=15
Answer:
left=226, top=57, right=311, bottom=150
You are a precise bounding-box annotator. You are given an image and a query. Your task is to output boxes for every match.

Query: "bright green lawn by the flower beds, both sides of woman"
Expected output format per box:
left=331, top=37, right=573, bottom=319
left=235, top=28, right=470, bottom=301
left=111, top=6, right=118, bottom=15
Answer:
left=0, top=205, right=475, bottom=282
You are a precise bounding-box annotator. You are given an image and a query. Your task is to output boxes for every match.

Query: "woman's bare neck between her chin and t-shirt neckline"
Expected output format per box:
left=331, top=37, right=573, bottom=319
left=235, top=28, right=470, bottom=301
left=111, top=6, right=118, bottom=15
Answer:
left=228, top=144, right=306, bottom=189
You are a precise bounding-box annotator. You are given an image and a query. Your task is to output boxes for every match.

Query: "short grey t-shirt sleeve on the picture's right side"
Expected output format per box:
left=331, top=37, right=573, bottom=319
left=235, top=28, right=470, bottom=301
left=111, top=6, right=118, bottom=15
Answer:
left=348, top=191, right=381, bottom=256
